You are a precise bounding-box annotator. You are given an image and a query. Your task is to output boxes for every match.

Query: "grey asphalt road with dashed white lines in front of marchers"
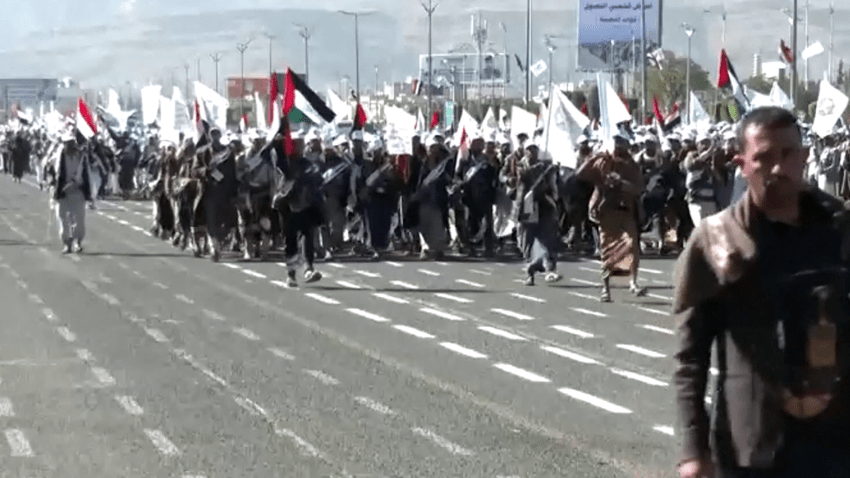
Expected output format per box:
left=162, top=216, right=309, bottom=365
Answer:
left=0, top=177, right=688, bottom=478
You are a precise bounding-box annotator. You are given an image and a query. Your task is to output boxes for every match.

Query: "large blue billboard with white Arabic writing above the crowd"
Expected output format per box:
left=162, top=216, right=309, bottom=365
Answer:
left=577, top=0, right=662, bottom=71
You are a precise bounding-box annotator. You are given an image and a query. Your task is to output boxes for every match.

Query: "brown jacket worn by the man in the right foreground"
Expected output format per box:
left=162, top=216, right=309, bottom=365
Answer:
left=673, top=186, right=850, bottom=468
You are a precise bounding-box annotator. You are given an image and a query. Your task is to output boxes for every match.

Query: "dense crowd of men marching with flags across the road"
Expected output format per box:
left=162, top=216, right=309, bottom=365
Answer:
left=9, top=105, right=850, bottom=301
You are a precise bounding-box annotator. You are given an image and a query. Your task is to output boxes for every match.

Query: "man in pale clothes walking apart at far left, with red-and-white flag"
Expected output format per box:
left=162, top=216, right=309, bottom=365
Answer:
left=53, top=98, right=97, bottom=254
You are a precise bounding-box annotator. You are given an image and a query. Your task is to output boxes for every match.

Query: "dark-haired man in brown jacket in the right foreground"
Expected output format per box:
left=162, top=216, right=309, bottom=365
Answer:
left=673, top=107, right=850, bottom=478
